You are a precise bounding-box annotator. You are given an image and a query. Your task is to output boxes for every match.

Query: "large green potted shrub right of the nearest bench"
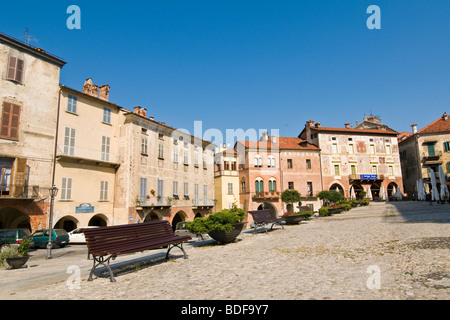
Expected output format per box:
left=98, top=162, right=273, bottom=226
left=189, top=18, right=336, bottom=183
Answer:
left=187, top=205, right=247, bottom=244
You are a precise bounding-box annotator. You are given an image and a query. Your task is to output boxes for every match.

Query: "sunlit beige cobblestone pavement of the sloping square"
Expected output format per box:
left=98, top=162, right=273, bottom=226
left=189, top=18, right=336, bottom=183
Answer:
left=0, top=202, right=450, bottom=300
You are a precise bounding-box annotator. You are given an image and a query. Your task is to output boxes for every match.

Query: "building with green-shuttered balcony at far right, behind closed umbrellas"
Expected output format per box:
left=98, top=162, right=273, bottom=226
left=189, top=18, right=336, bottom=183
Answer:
left=398, top=112, right=450, bottom=198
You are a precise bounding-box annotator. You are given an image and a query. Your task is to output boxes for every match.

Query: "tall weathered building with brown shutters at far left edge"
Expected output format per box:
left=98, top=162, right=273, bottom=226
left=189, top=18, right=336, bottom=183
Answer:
left=0, top=34, right=65, bottom=230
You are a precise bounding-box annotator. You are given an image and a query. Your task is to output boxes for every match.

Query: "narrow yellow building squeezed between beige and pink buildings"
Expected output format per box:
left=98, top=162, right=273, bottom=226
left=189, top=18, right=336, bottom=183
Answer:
left=214, top=148, right=242, bottom=211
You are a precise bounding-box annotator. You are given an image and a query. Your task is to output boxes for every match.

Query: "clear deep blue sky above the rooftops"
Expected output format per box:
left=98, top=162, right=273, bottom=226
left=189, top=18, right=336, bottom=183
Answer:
left=0, top=0, right=450, bottom=140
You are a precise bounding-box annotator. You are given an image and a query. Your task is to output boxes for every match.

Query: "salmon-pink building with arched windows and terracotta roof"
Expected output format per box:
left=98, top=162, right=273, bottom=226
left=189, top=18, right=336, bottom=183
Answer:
left=235, top=134, right=322, bottom=221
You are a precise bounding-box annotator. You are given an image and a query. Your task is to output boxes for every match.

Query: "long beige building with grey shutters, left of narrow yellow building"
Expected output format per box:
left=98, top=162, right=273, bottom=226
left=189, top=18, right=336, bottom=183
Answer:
left=114, top=107, right=215, bottom=228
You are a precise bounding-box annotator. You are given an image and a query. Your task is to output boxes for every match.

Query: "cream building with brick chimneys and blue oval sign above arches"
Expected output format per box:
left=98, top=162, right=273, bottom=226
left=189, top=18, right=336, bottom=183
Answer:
left=53, top=79, right=121, bottom=231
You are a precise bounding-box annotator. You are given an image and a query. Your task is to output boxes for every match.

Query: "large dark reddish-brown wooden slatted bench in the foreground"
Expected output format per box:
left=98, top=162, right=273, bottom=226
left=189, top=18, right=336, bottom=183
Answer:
left=84, top=220, right=192, bottom=282
